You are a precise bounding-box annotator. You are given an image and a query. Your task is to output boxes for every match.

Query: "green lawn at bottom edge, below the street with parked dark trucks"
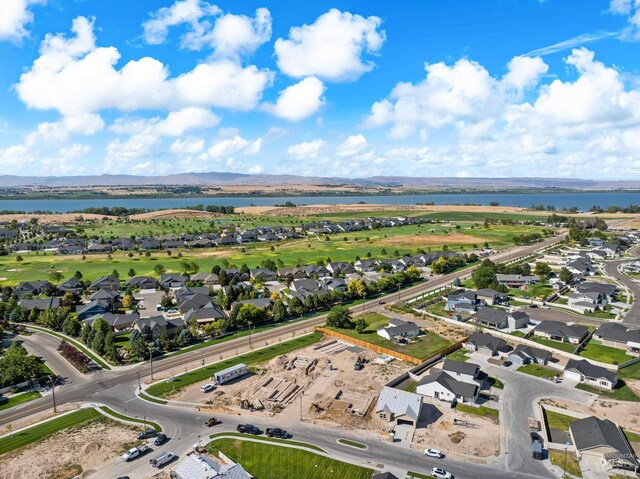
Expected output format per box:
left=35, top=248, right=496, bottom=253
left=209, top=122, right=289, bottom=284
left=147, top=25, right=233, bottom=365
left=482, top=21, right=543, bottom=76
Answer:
left=207, top=439, right=373, bottom=479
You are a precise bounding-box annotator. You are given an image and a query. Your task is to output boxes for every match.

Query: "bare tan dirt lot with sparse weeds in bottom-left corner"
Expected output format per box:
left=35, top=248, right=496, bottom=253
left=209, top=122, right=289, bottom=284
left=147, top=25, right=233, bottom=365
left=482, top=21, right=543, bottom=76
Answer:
left=0, top=421, right=135, bottom=479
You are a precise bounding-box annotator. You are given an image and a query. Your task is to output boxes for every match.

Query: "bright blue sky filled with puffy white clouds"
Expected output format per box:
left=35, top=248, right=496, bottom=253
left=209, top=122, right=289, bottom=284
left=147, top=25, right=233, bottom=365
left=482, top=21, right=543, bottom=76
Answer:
left=0, top=0, right=640, bottom=180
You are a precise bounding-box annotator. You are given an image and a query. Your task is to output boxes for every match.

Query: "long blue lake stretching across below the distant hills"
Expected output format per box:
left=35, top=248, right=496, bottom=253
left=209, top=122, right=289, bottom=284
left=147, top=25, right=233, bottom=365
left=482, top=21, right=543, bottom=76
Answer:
left=0, top=192, right=640, bottom=213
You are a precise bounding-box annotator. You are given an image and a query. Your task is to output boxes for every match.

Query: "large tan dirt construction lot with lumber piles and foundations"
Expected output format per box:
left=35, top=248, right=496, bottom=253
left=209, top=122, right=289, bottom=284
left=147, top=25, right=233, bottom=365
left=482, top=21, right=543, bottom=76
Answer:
left=175, top=340, right=411, bottom=428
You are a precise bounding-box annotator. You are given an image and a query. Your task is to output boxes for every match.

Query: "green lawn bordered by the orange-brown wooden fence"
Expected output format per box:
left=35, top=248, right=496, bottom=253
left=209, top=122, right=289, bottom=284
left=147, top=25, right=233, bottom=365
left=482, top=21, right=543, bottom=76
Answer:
left=327, top=313, right=452, bottom=359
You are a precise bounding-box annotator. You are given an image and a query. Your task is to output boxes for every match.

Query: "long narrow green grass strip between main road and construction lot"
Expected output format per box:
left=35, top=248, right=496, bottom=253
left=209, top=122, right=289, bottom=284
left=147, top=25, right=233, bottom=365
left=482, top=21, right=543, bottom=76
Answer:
left=146, top=333, right=323, bottom=397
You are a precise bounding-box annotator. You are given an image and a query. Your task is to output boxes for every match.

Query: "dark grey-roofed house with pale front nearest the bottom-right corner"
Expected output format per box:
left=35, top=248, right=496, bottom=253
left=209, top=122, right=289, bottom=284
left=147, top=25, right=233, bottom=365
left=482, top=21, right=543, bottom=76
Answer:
left=569, top=416, right=640, bottom=470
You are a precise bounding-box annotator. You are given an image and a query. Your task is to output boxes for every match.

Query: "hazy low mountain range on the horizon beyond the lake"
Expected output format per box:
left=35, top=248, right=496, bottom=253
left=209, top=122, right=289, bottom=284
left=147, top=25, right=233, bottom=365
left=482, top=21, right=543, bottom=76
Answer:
left=0, top=172, right=640, bottom=190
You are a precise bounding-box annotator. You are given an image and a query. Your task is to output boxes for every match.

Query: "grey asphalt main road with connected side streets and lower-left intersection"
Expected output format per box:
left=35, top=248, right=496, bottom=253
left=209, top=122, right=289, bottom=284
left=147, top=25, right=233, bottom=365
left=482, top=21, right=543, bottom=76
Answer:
left=0, top=234, right=558, bottom=478
